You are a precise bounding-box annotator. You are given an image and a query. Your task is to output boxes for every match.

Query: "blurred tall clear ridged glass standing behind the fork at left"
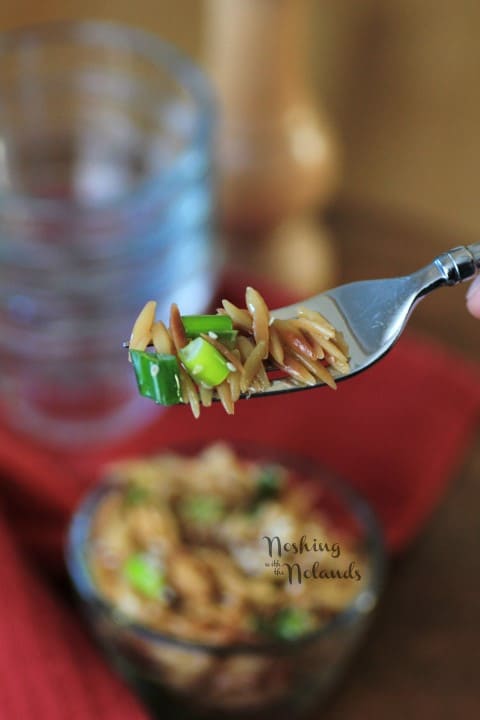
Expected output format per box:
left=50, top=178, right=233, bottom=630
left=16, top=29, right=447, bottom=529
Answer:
left=0, top=22, right=217, bottom=446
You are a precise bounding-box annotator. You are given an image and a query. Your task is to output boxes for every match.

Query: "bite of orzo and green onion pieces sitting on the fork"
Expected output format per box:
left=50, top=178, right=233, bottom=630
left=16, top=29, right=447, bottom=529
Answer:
left=129, top=287, right=349, bottom=417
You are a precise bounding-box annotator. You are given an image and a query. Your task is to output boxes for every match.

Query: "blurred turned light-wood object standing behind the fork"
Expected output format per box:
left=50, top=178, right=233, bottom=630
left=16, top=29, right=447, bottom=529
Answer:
left=206, top=0, right=339, bottom=293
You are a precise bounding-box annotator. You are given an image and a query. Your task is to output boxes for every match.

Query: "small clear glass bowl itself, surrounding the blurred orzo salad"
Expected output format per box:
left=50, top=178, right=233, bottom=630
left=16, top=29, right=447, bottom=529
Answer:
left=66, top=444, right=385, bottom=720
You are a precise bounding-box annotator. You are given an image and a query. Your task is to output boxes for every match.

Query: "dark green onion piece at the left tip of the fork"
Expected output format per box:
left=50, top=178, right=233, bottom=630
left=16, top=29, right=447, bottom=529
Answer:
left=130, top=350, right=182, bottom=405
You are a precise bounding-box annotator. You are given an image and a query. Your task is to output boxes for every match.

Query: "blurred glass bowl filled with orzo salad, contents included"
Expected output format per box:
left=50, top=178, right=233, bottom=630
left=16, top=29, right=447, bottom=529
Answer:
left=67, top=443, right=384, bottom=719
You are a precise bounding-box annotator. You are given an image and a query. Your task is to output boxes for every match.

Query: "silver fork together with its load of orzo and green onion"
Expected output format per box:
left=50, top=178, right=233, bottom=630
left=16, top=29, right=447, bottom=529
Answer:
left=126, top=243, right=480, bottom=415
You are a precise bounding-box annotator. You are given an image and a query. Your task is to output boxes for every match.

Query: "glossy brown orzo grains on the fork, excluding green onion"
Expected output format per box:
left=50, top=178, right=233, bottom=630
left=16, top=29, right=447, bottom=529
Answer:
left=130, top=287, right=349, bottom=417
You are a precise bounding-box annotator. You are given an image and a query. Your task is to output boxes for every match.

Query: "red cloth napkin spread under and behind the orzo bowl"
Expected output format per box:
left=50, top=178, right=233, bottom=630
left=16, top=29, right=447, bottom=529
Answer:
left=0, top=272, right=480, bottom=720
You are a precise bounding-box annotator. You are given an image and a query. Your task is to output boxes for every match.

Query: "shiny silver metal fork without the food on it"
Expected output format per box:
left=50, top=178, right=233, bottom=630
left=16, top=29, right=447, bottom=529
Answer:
left=258, top=243, right=480, bottom=397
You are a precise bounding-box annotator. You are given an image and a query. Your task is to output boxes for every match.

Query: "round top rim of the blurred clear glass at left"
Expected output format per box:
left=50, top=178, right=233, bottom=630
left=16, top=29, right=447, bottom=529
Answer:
left=0, top=19, right=217, bottom=215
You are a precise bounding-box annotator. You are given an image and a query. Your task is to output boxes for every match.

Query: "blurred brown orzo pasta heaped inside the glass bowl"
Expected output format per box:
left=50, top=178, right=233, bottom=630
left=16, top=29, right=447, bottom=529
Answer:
left=89, top=443, right=365, bottom=644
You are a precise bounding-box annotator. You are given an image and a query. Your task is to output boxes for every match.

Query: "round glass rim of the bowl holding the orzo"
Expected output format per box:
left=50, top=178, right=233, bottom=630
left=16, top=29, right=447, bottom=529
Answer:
left=65, top=440, right=387, bottom=656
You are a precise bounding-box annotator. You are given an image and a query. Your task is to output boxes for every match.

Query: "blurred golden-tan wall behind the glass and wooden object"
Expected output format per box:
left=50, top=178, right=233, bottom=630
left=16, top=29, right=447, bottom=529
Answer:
left=0, top=0, right=480, bottom=234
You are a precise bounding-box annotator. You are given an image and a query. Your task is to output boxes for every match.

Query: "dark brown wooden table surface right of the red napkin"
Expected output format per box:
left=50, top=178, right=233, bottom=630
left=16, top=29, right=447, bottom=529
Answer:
left=313, top=205, right=480, bottom=720
